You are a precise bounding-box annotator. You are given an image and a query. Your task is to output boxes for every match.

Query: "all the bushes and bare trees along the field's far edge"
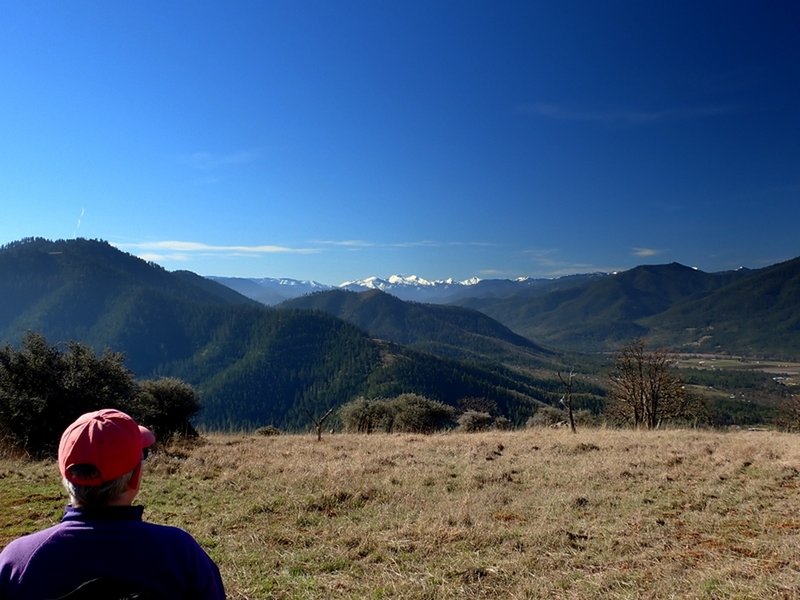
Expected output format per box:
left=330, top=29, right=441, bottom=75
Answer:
left=0, top=333, right=800, bottom=457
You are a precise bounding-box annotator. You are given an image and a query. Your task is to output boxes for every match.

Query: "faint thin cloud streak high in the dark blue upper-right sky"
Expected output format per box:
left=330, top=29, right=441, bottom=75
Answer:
left=520, top=102, right=735, bottom=126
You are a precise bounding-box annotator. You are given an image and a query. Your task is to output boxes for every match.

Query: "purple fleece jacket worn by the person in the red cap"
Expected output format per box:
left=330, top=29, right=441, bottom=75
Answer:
left=0, top=506, right=225, bottom=600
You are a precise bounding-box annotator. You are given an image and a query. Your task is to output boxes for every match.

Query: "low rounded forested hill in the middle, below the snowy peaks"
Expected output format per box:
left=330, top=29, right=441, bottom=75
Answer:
left=276, top=290, right=552, bottom=365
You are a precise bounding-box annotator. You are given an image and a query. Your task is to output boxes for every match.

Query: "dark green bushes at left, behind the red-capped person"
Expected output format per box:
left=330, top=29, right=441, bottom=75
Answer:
left=0, top=333, right=200, bottom=457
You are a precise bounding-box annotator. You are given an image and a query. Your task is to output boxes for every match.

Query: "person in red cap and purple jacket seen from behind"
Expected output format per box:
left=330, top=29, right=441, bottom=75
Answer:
left=0, top=409, right=225, bottom=600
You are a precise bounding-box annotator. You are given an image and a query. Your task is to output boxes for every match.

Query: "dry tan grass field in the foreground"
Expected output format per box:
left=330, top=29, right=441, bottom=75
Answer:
left=0, top=429, right=800, bottom=599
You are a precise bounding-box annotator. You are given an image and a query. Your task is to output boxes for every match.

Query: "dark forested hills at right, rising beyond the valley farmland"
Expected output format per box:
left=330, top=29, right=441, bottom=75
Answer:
left=456, top=258, right=800, bottom=358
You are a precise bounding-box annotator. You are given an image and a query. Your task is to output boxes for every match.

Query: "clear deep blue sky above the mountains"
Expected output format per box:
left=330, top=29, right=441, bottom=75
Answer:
left=0, top=0, right=800, bottom=284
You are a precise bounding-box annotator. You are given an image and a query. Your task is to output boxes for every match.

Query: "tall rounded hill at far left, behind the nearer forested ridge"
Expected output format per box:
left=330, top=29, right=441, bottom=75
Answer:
left=0, top=239, right=253, bottom=373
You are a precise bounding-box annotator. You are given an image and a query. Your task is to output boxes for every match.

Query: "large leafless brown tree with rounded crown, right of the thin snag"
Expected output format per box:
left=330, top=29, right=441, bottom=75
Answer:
left=610, top=340, right=697, bottom=429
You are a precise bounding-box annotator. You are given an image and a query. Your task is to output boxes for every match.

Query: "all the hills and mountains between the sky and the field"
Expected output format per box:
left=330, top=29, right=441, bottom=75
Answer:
left=0, top=238, right=800, bottom=430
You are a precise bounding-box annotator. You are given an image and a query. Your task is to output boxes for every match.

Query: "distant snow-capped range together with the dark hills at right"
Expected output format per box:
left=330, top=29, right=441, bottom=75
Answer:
left=212, top=258, right=800, bottom=358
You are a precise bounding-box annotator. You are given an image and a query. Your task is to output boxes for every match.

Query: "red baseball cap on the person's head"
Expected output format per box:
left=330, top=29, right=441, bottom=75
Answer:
left=58, top=408, right=156, bottom=486
